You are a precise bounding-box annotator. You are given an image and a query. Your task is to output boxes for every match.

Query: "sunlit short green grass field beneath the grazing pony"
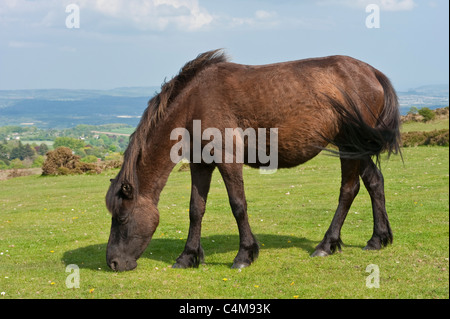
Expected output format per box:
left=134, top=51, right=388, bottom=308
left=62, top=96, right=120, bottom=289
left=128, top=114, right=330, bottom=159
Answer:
left=0, top=147, right=449, bottom=299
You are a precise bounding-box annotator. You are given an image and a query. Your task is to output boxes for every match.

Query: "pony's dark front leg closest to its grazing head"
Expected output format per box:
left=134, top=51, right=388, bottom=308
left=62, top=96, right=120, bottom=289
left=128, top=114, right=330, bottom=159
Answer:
left=172, top=163, right=214, bottom=268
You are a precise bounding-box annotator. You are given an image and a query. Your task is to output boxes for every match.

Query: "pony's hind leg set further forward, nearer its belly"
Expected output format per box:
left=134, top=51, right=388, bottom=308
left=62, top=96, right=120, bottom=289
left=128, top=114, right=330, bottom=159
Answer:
left=311, top=158, right=360, bottom=257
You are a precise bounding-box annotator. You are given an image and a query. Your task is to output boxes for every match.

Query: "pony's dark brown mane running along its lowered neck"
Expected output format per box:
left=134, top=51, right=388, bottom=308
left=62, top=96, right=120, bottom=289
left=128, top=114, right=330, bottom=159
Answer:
left=116, top=49, right=227, bottom=192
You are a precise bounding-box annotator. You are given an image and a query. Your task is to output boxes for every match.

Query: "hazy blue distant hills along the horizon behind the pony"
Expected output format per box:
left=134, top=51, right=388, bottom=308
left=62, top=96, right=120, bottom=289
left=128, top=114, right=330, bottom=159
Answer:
left=0, top=85, right=449, bottom=129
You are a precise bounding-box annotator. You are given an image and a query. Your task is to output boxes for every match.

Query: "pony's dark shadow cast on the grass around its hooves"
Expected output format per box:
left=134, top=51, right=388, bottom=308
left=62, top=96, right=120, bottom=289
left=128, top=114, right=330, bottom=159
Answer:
left=62, top=234, right=318, bottom=271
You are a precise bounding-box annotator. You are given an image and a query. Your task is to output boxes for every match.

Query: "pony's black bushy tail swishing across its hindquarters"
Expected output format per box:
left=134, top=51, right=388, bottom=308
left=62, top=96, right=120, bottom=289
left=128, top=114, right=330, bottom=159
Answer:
left=327, top=70, right=401, bottom=165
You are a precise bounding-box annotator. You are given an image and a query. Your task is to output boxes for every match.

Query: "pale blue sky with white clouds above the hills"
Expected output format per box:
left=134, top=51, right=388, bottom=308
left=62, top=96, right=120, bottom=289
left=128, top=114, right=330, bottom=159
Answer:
left=0, top=0, right=449, bottom=91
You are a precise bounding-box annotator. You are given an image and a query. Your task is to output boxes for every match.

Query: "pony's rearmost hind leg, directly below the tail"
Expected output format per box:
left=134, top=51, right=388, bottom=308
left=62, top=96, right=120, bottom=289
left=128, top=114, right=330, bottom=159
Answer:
left=360, top=158, right=393, bottom=250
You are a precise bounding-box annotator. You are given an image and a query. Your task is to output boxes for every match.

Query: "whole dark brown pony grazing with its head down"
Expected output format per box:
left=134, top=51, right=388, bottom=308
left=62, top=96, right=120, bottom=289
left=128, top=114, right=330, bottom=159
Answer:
left=106, top=50, right=400, bottom=271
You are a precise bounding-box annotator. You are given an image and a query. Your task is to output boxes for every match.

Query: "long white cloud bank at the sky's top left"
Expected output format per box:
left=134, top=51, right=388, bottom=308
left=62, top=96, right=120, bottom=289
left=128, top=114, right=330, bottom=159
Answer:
left=0, top=0, right=213, bottom=31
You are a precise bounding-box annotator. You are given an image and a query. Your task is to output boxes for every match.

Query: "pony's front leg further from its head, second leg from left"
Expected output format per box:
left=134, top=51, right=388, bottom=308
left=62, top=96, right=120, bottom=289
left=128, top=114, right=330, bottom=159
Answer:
left=217, top=163, right=259, bottom=268
